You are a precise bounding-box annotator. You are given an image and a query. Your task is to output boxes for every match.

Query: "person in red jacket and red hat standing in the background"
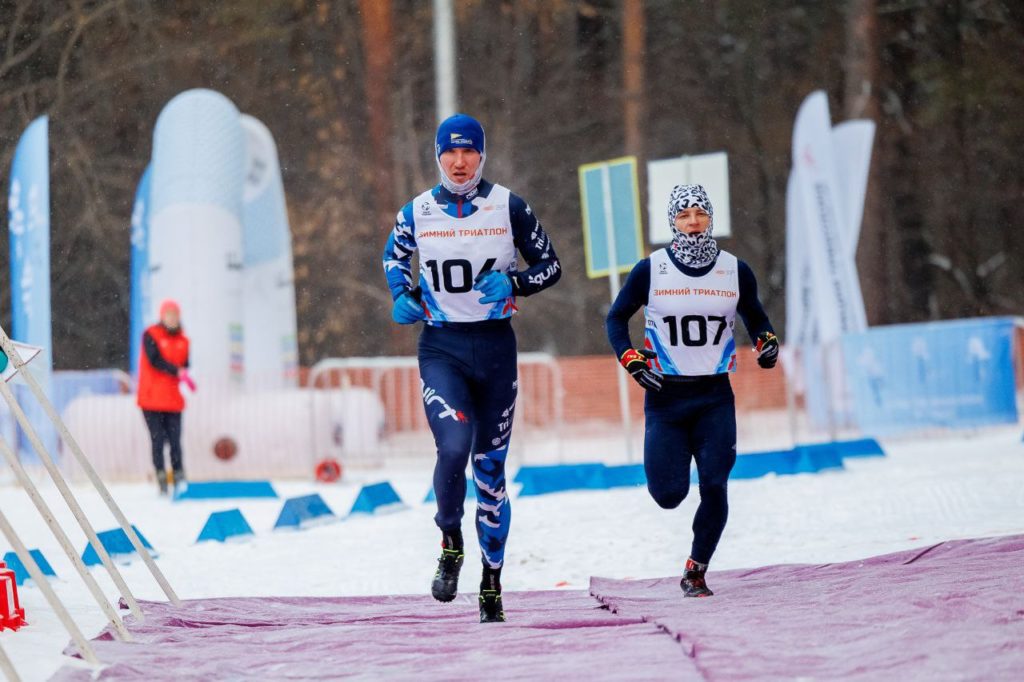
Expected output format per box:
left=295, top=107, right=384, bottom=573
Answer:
left=138, top=300, right=195, bottom=495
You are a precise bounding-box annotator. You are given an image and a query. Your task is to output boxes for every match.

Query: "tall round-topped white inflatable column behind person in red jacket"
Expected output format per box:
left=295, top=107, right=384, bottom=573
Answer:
left=148, top=89, right=246, bottom=387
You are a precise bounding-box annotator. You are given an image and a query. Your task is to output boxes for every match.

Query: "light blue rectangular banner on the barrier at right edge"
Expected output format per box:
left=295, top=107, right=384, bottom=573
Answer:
left=843, top=317, right=1020, bottom=435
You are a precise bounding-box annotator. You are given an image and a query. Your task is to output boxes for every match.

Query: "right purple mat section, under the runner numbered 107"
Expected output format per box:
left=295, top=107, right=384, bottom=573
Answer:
left=591, top=536, right=1024, bottom=680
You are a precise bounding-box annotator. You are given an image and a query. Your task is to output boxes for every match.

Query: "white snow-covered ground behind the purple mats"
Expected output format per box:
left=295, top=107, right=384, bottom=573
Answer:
left=0, top=428, right=1024, bottom=680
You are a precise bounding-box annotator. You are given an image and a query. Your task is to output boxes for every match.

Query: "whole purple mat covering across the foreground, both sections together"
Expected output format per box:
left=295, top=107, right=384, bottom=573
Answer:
left=53, top=536, right=1024, bottom=682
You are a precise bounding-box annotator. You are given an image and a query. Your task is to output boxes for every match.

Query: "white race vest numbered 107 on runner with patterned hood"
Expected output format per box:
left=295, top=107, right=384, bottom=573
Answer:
left=644, top=249, right=739, bottom=377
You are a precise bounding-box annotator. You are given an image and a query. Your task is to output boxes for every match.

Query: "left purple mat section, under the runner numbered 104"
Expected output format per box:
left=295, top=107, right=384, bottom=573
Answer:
left=52, top=591, right=700, bottom=680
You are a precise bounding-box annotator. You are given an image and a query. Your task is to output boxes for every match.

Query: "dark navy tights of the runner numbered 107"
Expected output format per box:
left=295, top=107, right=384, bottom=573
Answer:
left=644, top=374, right=736, bottom=563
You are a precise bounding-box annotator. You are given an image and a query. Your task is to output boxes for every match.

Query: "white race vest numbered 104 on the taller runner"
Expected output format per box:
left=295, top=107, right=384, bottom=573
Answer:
left=413, top=184, right=518, bottom=324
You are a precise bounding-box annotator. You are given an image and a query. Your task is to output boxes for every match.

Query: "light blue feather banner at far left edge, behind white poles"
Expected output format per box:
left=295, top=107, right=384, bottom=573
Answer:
left=7, top=116, right=57, bottom=461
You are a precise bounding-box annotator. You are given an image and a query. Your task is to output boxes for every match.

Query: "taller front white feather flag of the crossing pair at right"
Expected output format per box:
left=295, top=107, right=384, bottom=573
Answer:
left=793, top=91, right=867, bottom=343
